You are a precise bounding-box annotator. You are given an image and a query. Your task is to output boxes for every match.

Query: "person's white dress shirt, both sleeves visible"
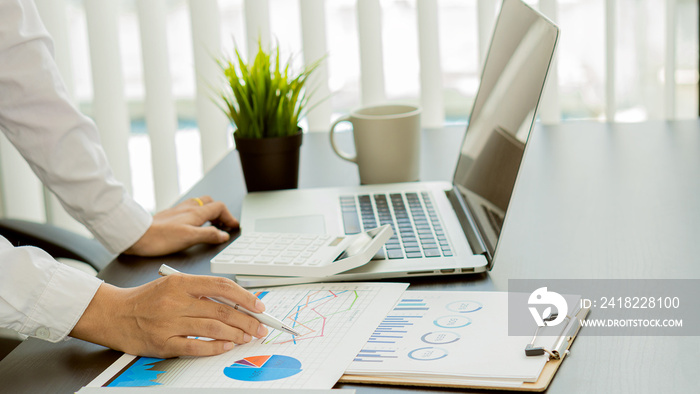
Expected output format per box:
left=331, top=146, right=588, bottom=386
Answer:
left=0, top=0, right=152, bottom=342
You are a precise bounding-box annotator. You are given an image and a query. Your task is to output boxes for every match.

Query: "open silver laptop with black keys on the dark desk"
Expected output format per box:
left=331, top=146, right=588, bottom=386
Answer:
left=236, top=0, right=559, bottom=287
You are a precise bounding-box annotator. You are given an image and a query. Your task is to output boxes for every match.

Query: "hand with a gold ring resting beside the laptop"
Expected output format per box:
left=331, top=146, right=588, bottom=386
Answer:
left=124, top=196, right=238, bottom=256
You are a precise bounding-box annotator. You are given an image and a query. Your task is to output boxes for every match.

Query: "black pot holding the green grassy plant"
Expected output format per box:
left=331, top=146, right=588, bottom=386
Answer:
left=233, top=129, right=303, bottom=192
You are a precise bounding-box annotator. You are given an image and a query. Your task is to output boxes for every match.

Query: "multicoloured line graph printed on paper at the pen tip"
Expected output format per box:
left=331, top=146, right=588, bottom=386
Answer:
left=263, top=290, right=360, bottom=344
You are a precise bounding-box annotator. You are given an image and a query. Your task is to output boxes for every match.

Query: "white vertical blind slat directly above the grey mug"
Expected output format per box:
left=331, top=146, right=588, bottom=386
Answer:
left=357, top=0, right=386, bottom=105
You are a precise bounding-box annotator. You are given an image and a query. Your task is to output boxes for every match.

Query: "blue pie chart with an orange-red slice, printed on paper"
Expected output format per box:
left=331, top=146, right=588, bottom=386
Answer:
left=224, top=354, right=301, bottom=382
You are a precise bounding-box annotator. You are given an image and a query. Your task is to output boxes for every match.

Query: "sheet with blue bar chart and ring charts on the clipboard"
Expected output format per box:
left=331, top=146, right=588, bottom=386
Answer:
left=345, top=291, right=580, bottom=387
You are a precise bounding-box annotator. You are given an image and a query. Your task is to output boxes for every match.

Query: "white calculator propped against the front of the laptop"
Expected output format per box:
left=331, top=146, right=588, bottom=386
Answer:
left=211, top=225, right=394, bottom=278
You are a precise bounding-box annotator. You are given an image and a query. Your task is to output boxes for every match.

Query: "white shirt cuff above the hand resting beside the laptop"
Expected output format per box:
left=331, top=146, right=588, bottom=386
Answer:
left=88, top=195, right=153, bottom=254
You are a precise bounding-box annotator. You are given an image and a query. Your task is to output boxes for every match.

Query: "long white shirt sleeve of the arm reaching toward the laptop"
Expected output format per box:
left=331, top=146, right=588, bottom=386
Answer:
left=0, top=0, right=152, bottom=253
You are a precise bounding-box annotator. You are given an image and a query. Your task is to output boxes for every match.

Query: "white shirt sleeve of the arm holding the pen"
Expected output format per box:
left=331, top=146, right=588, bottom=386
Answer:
left=0, top=237, right=102, bottom=342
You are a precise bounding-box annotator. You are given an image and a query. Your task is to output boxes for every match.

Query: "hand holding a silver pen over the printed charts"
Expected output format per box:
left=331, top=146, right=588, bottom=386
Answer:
left=70, top=274, right=267, bottom=358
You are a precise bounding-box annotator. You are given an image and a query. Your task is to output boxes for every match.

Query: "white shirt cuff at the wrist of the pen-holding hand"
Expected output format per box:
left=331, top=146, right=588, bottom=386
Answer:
left=19, top=264, right=102, bottom=342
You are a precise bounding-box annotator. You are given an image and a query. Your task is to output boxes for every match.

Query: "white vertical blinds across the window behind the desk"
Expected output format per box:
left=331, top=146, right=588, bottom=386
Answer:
left=0, top=0, right=679, bottom=231
